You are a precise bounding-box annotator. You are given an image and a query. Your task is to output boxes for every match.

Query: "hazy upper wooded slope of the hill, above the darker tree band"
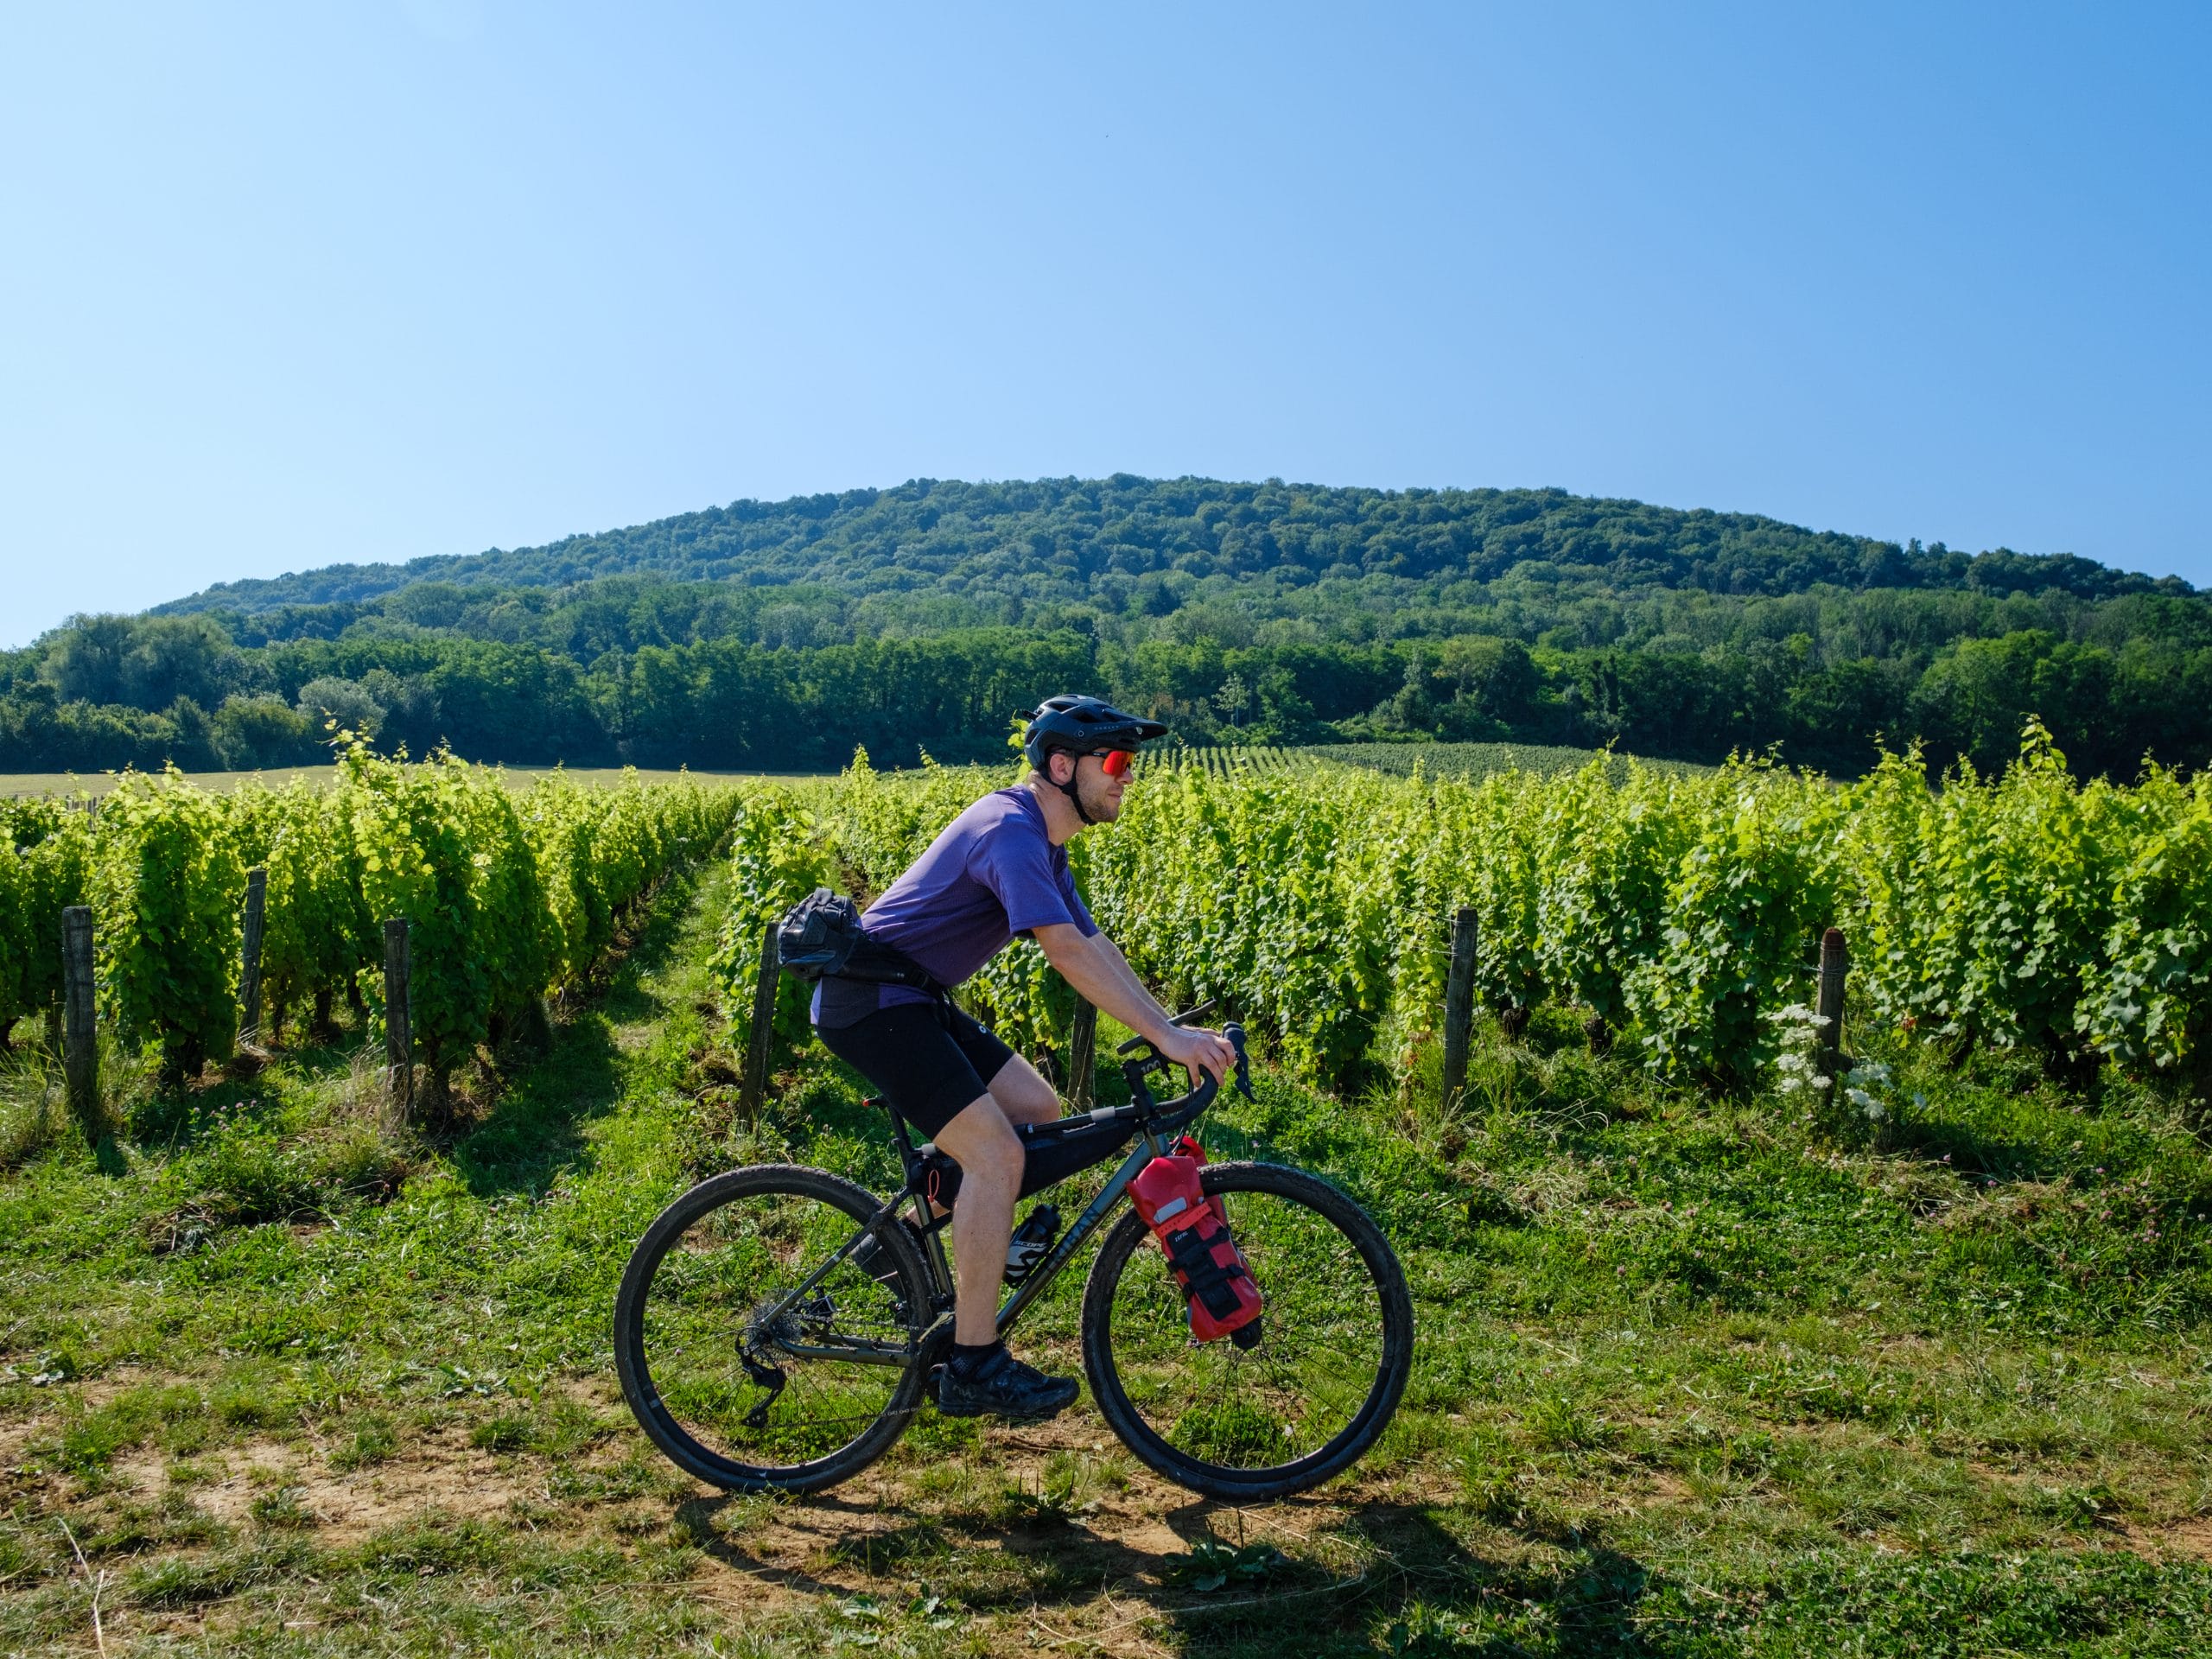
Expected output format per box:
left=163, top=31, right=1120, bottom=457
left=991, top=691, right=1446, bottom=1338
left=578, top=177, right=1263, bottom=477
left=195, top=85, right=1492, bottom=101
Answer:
left=157, top=474, right=2190, bottom=628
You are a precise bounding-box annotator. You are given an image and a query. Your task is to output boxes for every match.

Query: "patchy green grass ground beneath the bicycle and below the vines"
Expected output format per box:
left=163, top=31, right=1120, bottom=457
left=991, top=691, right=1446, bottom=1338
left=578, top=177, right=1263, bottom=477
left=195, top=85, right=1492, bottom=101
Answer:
left=0, top=880, right=2212, bottom=1659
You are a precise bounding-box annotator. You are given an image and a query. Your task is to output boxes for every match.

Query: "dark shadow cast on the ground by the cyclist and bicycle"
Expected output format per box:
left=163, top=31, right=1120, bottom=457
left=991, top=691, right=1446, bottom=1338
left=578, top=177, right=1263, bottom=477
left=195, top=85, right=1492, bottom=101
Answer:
left=671, top=1493, right=1670, bottom=1659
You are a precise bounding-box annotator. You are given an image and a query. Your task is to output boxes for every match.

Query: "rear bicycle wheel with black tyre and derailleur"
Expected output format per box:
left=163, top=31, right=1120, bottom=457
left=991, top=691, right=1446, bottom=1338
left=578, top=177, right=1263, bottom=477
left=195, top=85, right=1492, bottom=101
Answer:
left=615, top=1164, right=929, bottom=1491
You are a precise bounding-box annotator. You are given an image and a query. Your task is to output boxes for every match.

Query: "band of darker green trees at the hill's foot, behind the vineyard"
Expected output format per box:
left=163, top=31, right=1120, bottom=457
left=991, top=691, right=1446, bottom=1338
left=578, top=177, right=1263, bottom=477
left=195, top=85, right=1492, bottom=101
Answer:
left=0, top=615, right=2212, bottom=779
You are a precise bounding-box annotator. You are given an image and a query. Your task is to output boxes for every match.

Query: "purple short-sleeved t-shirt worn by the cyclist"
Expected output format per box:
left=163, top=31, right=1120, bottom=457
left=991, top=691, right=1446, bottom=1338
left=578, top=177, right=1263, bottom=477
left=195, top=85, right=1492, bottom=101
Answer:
left=814, top=787, right=1099, bottom=1031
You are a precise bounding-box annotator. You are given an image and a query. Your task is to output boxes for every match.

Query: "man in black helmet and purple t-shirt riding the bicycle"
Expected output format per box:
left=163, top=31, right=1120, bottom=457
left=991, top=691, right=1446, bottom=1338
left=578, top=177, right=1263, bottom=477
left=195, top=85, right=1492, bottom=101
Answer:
left=814, top=696, right=1236, bottom=1421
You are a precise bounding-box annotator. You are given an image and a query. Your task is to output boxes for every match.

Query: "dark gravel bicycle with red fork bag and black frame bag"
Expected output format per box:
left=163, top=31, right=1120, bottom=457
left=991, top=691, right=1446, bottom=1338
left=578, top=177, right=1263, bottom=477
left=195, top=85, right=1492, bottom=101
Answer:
left=615, top=1008, right=1414, bottom=1502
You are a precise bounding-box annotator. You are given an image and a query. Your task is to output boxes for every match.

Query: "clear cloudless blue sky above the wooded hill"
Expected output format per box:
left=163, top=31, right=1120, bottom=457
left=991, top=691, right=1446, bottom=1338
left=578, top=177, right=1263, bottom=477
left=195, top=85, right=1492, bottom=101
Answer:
left=0, top=0, right=2212, bottom=644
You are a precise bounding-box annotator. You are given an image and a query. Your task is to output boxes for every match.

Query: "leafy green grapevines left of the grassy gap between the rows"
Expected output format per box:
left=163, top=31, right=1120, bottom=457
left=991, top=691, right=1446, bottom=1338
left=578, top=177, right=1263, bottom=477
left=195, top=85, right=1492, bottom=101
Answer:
left=0, top=747, right=736, bottom=1089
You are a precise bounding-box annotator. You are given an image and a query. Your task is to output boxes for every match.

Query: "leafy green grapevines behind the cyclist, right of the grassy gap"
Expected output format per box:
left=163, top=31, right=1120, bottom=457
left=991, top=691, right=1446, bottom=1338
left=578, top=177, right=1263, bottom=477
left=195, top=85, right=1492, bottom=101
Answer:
left=719, top=728, right=2212, bottom=1106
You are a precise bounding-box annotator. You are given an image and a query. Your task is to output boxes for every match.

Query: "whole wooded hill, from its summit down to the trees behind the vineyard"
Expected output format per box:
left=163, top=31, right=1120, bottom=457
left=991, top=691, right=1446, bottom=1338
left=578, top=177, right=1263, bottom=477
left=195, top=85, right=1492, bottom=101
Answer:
left=0, top=475, right=2212, bottom=777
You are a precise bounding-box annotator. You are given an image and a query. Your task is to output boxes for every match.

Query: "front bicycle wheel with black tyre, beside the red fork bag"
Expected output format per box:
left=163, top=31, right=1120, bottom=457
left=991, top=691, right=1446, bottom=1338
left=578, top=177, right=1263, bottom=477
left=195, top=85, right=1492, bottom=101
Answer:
left=1084, top=1164, right=1414, bottom=1502
